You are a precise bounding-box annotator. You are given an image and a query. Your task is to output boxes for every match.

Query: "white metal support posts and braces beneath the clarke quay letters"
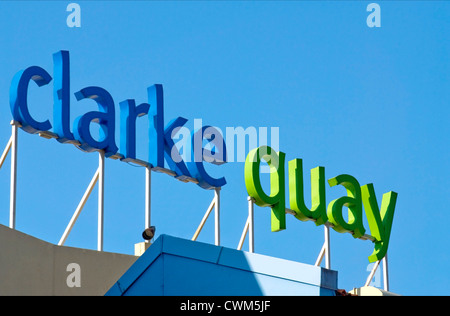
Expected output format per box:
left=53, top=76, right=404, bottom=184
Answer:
left=0, top=120, right=389, bottom=291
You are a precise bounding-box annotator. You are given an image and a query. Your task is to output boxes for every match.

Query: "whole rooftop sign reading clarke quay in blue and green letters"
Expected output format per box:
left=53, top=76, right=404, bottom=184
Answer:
left=10, top=51, right=397, bottom=262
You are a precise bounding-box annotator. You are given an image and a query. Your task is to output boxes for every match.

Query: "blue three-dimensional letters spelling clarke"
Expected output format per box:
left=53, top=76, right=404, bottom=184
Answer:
left=9, top=51, right=226, bottom=189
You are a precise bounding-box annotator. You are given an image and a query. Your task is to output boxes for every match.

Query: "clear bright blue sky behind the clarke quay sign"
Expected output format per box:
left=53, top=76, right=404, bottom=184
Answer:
left=0, top=1, right=450, bottom=295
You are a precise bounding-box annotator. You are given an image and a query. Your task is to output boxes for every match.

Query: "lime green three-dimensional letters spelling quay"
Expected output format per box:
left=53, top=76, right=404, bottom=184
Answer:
left=245, top=146, right=397, bottom=262
